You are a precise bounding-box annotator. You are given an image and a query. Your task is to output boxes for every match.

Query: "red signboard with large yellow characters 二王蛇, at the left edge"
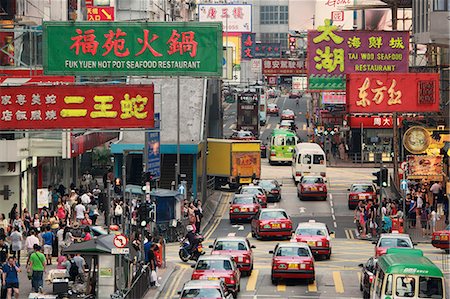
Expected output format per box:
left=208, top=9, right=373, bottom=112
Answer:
left=0, top=85, right=154, bottom=130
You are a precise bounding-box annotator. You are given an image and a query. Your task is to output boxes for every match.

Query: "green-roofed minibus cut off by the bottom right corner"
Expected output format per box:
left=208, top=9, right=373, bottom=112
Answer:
left=371, top=248, right=446, bottom=299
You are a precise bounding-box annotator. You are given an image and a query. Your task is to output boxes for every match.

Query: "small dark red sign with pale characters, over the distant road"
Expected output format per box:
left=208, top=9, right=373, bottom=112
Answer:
left=263, top=58, right=306, bottom=75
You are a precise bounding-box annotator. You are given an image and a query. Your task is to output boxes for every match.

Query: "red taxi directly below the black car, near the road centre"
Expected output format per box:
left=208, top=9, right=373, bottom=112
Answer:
left=251, top=208, right=292, bottom=239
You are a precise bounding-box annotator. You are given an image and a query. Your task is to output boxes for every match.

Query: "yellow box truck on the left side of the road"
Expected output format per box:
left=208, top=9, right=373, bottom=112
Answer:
left=207, top=138, right=261, bottom=189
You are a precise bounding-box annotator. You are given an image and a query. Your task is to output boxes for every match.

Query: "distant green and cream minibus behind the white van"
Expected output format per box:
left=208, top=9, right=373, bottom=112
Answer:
left=269, top=129, right=298, bottom=165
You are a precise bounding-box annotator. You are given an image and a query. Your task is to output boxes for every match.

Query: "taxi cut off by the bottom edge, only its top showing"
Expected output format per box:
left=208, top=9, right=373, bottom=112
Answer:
left=178, top=280, right=233, bottom=299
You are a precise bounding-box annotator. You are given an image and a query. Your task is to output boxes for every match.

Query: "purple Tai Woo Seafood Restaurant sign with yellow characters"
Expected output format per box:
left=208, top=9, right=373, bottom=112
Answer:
left=308, top=19, right=409, bottom=90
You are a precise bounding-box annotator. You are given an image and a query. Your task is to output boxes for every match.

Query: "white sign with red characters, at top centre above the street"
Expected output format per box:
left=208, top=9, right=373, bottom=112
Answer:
left=198, top=4, right=252, bottom=32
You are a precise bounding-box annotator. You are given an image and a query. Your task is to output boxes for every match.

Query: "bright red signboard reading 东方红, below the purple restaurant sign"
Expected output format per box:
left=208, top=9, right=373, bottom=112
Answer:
left=346, top=73, right=439, bottom=113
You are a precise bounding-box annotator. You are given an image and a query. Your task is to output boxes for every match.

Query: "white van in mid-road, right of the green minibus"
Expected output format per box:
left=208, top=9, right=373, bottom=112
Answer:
left=292, top=142, right=327, bottom=183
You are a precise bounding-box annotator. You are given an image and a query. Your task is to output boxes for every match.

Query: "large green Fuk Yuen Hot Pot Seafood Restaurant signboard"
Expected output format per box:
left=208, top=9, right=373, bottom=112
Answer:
left=43, top=22, right=223, bottom=76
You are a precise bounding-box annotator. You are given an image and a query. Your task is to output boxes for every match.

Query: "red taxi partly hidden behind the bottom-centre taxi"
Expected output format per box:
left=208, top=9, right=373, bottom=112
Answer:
left=291, top=220, right=334, bottom=259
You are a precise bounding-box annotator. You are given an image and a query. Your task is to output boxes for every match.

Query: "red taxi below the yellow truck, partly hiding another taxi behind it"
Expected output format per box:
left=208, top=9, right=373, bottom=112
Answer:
left=229, top=194, right=261, bottom=223
